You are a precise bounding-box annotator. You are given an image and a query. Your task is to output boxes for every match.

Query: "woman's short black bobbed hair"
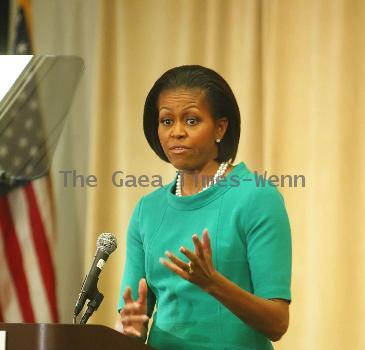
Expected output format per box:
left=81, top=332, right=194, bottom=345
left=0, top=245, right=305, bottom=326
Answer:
left=143, top=65, right=241, bottom=162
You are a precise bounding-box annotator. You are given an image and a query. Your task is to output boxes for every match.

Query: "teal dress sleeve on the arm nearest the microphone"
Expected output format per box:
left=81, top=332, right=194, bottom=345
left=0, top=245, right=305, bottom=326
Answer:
left=118, top=198, right=156, bottom=317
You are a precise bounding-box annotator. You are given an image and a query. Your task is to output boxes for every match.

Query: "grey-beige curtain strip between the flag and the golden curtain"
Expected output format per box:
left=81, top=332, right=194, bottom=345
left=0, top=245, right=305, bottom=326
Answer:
left=31, top=0, right=98, bottom=323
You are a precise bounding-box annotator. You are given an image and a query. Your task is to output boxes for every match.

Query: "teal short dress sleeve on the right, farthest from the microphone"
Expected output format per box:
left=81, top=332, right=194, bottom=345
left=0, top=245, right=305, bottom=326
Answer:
left=245, top=185, right=292, bottom=301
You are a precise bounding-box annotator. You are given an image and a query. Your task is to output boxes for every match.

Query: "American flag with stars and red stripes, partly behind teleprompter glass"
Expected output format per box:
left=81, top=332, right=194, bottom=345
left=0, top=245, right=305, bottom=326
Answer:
left=0, top=0, right=59, bottom=322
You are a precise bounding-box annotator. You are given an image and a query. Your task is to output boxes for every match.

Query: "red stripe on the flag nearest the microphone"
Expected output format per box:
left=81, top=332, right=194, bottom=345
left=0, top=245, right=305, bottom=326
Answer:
left=25, top=183, right=58, bottom=322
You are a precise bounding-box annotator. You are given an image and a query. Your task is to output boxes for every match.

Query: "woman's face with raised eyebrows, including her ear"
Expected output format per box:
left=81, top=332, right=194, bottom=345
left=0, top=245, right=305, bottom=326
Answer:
left=157, top=88, right=228, bottom=170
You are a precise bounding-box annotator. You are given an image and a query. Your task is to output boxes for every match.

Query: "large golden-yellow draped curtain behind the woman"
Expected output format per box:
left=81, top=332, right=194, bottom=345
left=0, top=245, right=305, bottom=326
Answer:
left=32, top=0, right=365, bottom=350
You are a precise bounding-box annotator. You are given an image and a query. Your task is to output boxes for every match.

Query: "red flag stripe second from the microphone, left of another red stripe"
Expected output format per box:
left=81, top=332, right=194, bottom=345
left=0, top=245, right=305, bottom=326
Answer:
left=0, top=197, right=35, bottom=322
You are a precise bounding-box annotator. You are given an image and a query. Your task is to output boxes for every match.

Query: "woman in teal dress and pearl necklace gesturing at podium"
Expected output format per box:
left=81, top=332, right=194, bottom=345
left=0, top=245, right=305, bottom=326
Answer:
left=119, top=66, right=291, bottom=350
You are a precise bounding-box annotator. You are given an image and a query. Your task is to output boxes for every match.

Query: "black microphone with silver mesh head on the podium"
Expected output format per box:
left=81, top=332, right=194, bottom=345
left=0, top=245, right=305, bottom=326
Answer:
left=74, top=233, right=117, bottom=320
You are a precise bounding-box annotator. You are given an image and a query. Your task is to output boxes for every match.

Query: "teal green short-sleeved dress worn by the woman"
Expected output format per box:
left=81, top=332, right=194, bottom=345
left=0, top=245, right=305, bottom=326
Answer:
left=118, top=162, right=291, bottom=350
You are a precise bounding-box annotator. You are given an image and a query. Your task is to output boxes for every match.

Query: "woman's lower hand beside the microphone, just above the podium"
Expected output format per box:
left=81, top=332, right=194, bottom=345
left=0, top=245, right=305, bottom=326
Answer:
left=120, top=278, right=149, bottom=339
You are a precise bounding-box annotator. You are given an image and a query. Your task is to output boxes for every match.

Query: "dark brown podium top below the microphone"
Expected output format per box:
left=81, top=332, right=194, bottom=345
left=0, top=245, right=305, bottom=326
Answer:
left=0, top=323, right=153, bottom=350
